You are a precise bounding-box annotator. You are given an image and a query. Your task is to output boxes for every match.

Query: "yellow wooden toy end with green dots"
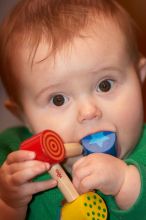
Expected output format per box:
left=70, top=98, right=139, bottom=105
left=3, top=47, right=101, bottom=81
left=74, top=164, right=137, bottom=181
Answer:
left=61, top=192, right=107, bottom=220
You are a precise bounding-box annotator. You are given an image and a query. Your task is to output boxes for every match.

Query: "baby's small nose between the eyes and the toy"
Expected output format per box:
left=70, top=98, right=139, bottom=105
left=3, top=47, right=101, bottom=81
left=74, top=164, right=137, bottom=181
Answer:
left=78, top=98, right=102, bottom=122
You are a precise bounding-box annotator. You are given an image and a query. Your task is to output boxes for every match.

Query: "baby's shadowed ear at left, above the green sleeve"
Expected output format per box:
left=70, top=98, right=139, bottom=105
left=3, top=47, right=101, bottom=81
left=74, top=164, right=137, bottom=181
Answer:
left=4, top=99, right=23, bottom=121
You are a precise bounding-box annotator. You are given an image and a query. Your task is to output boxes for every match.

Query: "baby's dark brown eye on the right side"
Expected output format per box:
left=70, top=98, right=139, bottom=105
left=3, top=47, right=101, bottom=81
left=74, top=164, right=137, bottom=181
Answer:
left=97, top=79, right=114, bottom=92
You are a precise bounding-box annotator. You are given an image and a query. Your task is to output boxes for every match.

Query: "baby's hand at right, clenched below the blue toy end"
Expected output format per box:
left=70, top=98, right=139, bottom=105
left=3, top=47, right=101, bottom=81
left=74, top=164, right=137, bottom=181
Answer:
left=73, top=153, right=128, bottom=195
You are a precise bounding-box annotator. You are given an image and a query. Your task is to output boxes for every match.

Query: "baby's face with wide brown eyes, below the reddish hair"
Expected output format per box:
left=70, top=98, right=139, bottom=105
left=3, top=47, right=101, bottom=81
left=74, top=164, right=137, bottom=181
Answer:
left=14, top=18, right=143, bottom=160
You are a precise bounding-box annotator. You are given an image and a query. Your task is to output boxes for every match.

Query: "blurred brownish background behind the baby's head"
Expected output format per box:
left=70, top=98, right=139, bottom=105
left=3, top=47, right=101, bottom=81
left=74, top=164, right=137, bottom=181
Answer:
left=0, top=0, right=146, bottom=131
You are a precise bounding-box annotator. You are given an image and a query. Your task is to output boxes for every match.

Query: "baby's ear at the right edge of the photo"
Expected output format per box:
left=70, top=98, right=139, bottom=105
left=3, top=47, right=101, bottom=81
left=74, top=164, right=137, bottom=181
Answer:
left=138, top=57, right=146, bottom=83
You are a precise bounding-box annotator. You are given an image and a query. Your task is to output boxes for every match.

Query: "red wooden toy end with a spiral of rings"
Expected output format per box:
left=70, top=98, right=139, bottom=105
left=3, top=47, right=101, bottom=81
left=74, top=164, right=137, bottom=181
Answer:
left=20, top=130, right=65, bottom=164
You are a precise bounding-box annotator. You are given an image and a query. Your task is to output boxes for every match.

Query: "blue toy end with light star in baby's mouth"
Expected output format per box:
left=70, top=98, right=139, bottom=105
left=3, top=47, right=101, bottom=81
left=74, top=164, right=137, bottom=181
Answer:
left=81, top=131, right=117, bottom=157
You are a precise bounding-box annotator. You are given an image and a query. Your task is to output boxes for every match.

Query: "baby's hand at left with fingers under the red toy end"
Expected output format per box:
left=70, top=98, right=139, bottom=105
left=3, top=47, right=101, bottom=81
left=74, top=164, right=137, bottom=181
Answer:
left=0, top=151, right=57, bottom=208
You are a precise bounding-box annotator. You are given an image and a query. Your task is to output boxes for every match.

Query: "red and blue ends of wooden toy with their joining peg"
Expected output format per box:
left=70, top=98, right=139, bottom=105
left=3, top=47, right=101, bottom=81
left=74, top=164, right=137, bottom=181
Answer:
left=20, top=130, right=117, bottom=161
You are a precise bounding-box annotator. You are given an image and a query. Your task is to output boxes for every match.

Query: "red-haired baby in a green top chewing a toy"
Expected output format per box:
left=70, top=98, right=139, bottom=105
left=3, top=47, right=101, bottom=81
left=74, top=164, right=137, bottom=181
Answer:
left=0, top=0, right=146, bottom=220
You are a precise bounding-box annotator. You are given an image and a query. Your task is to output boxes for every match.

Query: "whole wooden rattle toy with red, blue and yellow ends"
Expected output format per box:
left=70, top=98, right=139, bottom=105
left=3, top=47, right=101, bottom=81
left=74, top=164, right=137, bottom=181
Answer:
left=20, top=130, right=116, bottom=220
